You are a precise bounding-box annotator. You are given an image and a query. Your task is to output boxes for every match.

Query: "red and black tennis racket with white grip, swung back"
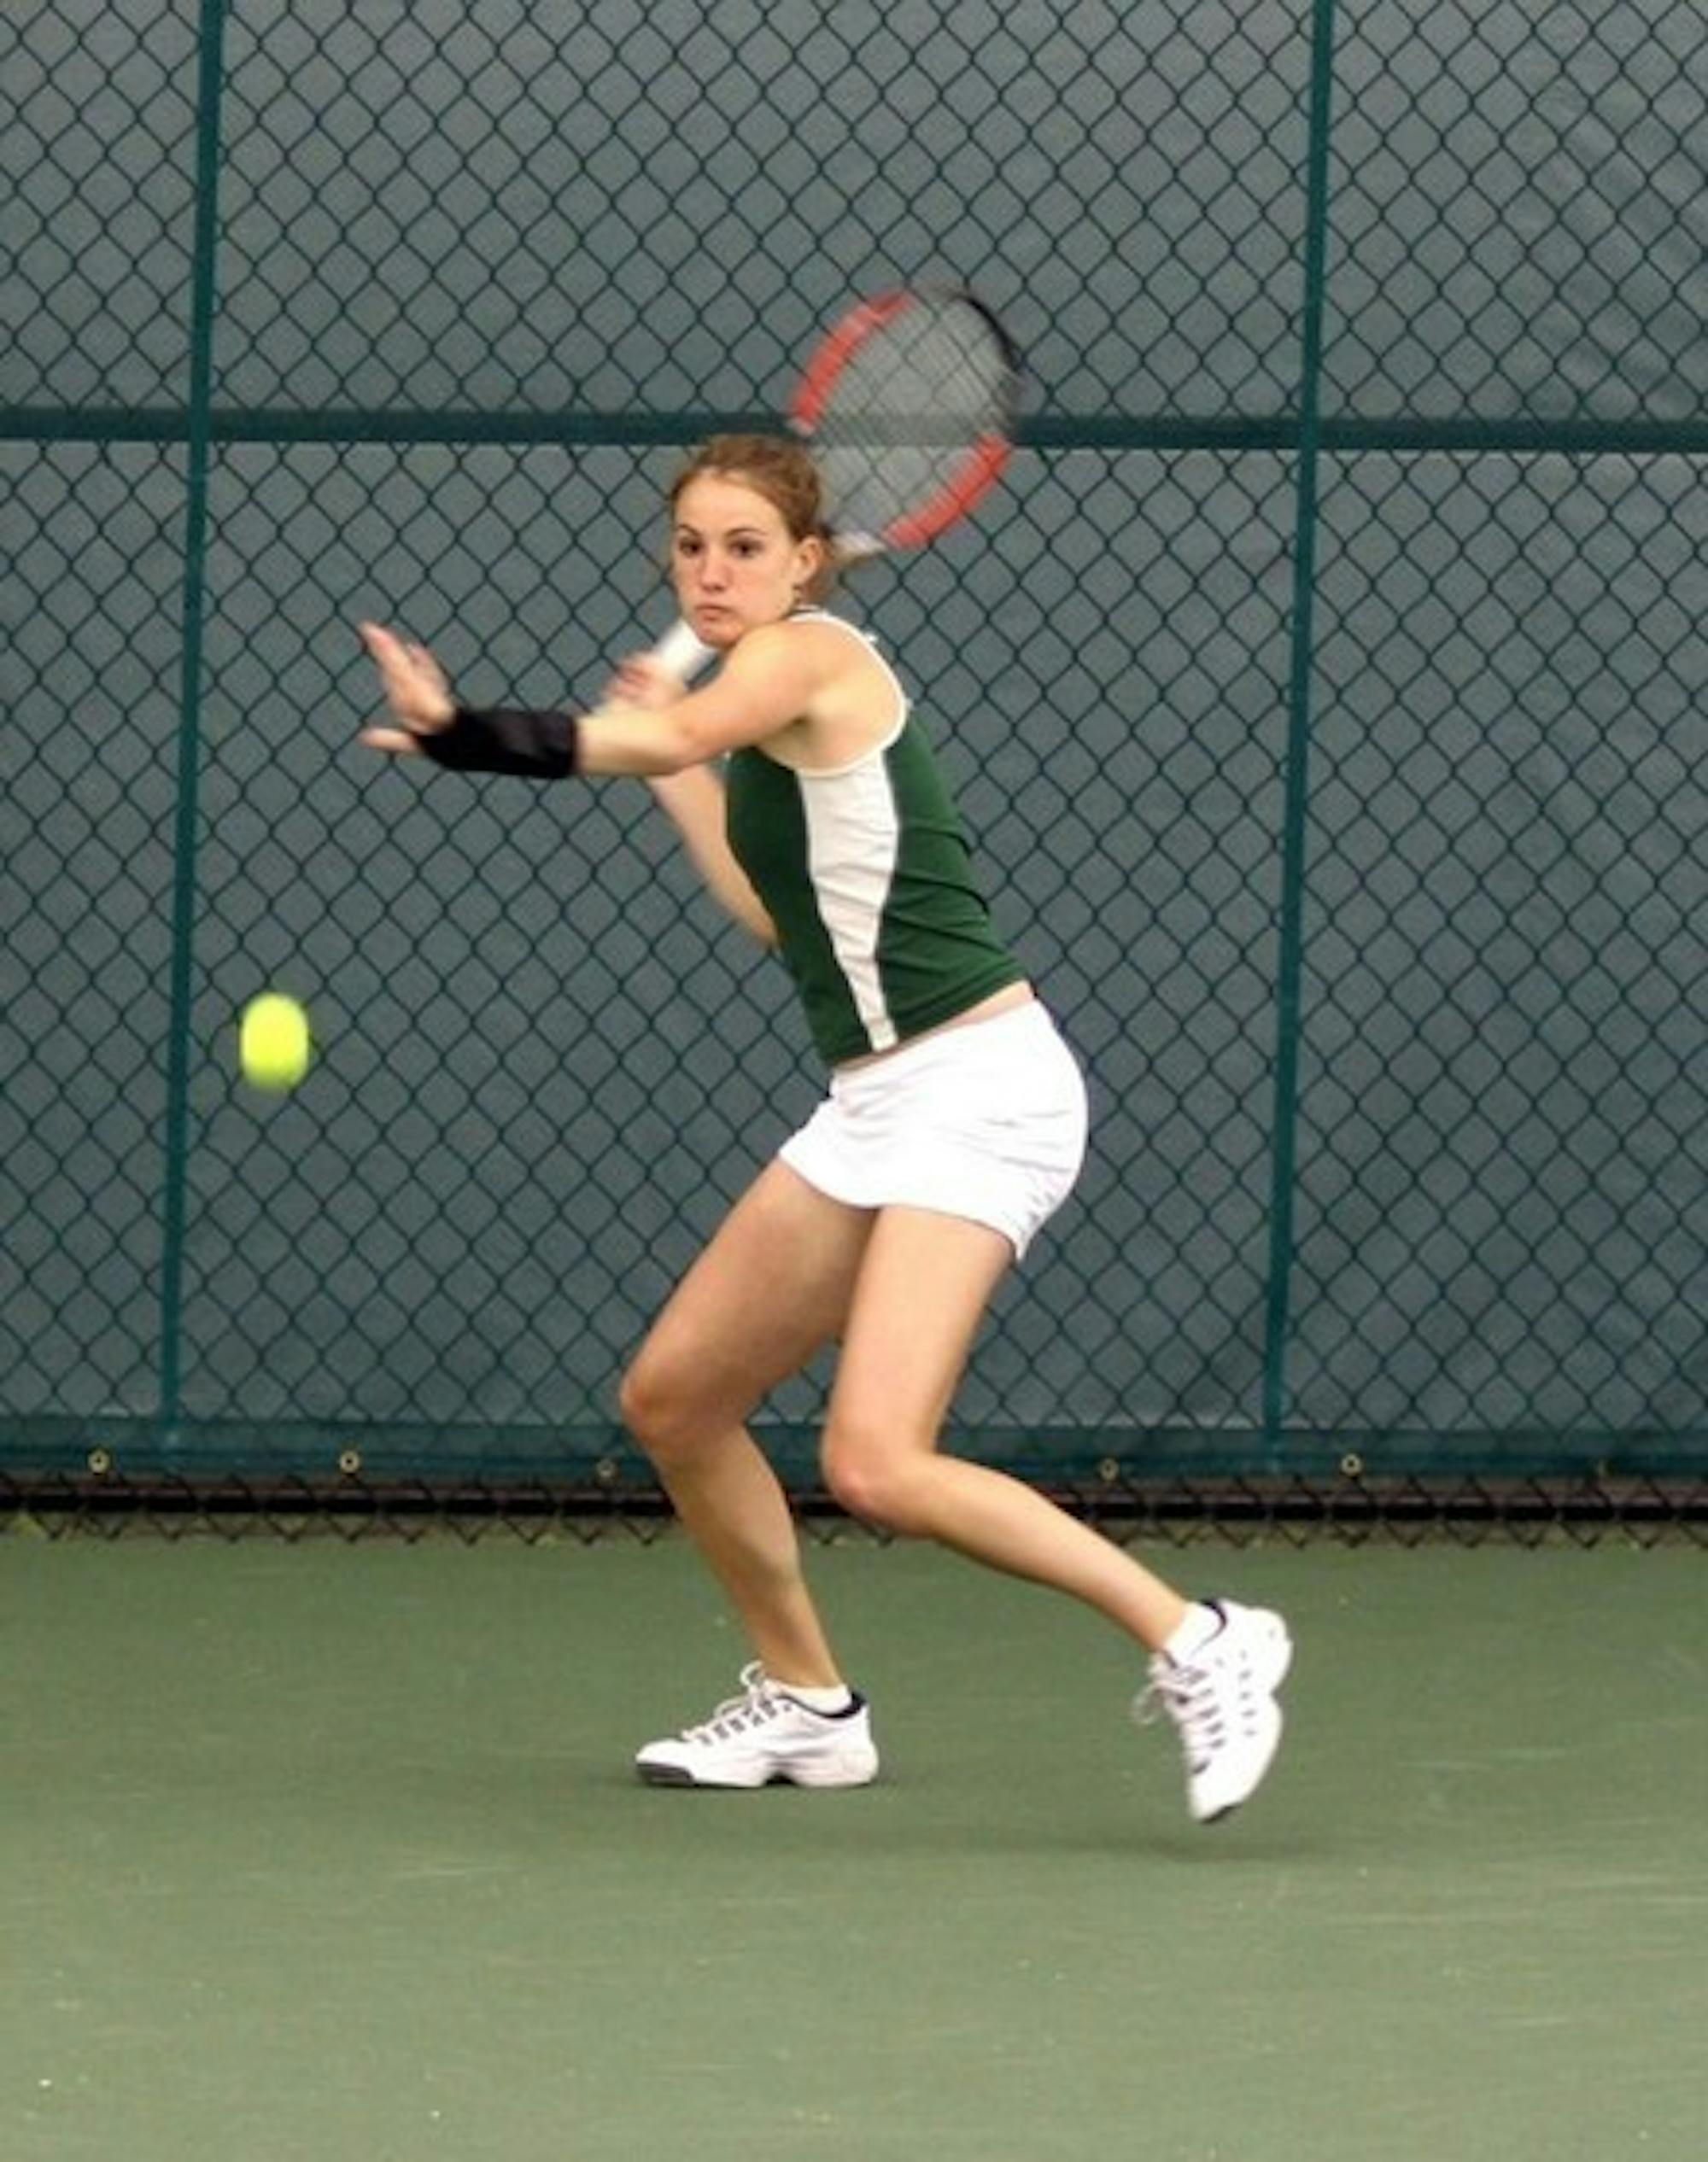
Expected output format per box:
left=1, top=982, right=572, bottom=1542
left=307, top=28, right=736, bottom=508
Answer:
left=653, top=285, right=1021, bottom=677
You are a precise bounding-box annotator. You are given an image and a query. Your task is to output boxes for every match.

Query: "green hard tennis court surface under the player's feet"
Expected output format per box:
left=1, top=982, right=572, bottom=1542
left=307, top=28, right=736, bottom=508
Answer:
left=0, top=1535, right=1708, bottom=2162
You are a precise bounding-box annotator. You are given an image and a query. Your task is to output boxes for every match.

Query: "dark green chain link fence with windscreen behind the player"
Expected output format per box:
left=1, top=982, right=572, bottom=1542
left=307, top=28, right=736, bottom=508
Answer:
left=0, top=0, right=1708, bottom=1527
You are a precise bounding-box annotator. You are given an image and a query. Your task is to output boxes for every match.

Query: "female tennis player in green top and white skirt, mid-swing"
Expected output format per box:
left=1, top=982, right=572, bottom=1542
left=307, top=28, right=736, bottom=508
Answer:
left=363, top=436, right=1290, bottom=1822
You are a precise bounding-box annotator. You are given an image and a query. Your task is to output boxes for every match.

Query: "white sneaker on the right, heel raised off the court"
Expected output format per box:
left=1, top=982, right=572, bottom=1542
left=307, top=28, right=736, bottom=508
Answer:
left=1133, top=1600, right=1293, bottom=1825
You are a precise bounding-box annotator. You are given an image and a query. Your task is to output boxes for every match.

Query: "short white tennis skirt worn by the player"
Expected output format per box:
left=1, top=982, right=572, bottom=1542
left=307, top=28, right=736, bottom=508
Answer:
left=778, top=999, right=1087, bottom=1260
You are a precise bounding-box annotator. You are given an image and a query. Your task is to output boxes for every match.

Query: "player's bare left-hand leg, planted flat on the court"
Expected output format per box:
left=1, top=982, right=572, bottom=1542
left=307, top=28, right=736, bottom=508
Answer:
left=623, top=1163, right=874, bottom=1688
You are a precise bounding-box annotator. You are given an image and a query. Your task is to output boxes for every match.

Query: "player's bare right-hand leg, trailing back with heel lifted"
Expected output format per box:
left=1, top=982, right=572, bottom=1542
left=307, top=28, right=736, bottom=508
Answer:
left=824, top=1208, right=1187, bottom=1651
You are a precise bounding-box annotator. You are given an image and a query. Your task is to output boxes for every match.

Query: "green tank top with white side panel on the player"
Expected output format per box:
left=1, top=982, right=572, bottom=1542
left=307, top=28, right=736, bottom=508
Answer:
left=724, top=610, right=1025, bottom=1066
